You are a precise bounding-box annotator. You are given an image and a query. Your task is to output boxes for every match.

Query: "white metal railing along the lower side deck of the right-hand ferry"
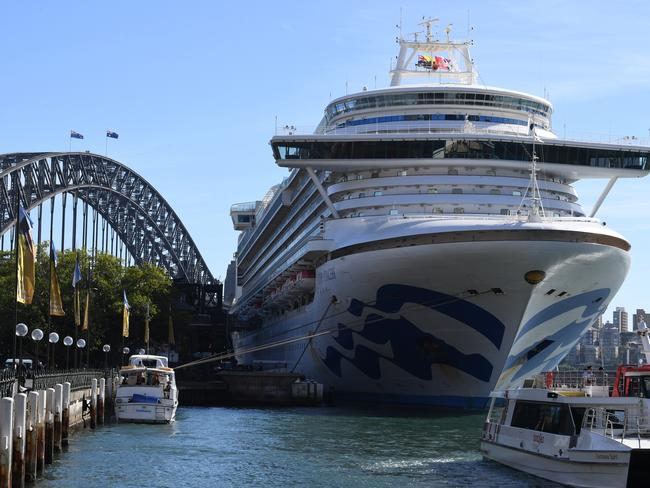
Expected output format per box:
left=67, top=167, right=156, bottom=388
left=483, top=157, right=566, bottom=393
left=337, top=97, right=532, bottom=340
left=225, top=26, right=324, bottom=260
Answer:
left=582, top=407, right=650, bottom=447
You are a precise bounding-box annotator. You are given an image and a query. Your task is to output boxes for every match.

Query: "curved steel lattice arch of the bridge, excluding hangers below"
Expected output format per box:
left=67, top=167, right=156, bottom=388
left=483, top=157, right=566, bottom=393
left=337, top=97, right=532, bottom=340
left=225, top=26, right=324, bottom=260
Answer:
left=0, top=152, right=217, bottom=285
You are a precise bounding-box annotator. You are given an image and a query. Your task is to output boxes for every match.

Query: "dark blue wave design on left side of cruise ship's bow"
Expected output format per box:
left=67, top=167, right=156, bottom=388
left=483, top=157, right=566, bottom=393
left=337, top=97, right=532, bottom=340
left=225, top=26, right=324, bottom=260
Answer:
left=321, top=284, right=505, bottom=382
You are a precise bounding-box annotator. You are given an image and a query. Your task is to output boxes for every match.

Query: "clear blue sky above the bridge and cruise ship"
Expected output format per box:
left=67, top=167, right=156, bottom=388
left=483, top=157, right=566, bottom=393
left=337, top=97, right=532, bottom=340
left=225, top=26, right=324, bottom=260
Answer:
left=0, top=0, right=650, bottom=320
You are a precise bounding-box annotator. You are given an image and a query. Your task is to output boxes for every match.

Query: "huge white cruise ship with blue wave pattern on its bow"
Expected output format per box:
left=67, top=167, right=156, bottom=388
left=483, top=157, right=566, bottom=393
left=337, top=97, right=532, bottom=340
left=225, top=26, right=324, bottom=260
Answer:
left=225, top=20, right=650, bottom=408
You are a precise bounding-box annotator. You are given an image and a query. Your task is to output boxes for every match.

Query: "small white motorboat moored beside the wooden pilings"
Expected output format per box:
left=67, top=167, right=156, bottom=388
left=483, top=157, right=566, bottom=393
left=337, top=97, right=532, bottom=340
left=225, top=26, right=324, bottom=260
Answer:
left=115, top=354, right=178, bottom=424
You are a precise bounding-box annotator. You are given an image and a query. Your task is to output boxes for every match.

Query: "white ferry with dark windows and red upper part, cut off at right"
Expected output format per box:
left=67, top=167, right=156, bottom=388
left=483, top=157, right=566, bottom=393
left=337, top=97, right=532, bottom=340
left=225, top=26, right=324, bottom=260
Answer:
left=481, top=365, right=650, bottom=488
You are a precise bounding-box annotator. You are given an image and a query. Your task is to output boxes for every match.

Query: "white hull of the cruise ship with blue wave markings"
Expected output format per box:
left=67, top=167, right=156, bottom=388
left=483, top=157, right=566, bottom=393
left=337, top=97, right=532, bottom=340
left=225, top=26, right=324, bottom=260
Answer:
left=234, top=219, right=629, bottom=408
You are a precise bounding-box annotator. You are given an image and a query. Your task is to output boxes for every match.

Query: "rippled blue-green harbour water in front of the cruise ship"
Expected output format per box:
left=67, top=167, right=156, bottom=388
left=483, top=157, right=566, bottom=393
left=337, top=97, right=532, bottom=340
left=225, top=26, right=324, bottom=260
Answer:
left=37, top=407, right=559, bottom=488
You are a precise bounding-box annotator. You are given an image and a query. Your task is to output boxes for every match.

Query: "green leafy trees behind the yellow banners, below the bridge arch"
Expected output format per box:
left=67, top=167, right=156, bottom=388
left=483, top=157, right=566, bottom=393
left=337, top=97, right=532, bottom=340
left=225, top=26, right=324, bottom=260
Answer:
left=0, top=243, right=172, bottom=364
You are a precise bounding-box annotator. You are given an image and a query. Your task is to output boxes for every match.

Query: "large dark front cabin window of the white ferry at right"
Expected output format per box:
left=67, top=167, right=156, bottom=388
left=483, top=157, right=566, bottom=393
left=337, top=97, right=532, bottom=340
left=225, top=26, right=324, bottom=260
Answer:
left=511, top=401, right=574, bottom=435
